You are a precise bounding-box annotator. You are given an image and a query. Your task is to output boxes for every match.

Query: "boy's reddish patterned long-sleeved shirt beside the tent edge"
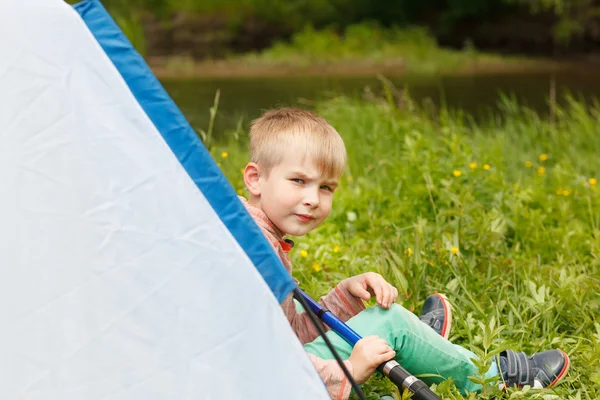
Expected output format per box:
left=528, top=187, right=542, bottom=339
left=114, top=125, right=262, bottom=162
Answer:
left=240, top=197, right=365, bottom=400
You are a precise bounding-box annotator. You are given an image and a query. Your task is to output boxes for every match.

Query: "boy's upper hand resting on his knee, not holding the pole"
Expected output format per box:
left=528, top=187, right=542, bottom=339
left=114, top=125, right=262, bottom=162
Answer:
left=342, top=272, right=398, bottom=308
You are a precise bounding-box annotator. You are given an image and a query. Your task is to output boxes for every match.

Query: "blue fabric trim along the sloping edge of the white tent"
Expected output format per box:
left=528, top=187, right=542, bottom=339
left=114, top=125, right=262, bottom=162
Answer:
left=73, top=0, right=296, bottom=302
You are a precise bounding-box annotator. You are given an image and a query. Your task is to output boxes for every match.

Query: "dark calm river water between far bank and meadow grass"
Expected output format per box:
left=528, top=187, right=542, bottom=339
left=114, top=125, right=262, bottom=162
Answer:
left=162, top=68, right=600, bottom=136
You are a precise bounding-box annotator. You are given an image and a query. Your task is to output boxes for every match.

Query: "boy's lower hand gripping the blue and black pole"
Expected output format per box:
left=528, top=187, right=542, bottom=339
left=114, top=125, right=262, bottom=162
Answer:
left=350, top=336, right=396, bottom=385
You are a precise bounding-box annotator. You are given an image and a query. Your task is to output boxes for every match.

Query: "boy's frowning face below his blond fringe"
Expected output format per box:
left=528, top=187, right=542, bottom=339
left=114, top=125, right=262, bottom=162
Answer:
left=252, top=150, right=339, bottom=236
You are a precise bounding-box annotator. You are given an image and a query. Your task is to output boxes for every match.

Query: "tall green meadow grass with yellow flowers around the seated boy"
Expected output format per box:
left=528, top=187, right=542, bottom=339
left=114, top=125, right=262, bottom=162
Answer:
left=212, top=88, right=600, bottom=399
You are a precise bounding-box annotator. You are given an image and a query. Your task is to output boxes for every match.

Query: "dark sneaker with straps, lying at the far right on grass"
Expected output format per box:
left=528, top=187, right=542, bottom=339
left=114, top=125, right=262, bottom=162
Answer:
left=497, top=350, right=571, bottom=389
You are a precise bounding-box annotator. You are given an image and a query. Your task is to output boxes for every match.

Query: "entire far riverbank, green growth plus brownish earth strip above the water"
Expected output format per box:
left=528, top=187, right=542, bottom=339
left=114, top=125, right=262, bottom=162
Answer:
left=148, top=24, right=568, bottom=78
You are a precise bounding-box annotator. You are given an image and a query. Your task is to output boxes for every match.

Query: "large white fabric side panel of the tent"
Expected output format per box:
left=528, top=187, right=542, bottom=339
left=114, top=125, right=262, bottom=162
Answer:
left=0, top=0, right=328, bottom=400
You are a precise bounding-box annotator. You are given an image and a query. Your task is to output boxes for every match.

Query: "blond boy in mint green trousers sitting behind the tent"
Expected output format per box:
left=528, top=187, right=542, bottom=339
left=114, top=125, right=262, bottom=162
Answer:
left=242, top=108, right=569, bottom=399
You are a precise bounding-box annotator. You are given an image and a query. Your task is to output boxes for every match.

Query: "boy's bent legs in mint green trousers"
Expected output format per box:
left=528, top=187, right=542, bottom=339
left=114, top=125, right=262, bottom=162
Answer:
left=304, top=304, right=498, bottom=392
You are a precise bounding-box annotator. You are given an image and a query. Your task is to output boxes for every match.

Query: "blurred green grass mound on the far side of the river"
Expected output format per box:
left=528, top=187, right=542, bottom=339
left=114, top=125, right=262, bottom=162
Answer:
left=234, top=23, right=524, bottom=73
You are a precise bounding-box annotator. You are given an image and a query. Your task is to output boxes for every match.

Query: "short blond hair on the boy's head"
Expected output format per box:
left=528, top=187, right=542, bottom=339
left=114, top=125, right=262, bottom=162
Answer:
left=250, top=108, right=346, bottom=177
